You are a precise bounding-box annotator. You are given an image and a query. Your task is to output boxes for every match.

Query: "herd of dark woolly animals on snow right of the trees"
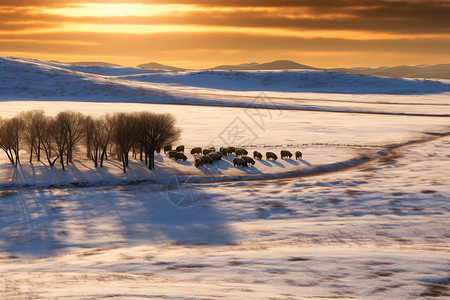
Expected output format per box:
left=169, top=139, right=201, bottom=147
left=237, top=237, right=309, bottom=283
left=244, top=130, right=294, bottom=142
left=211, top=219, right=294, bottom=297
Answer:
left=164, top=145, right=302, bottom=167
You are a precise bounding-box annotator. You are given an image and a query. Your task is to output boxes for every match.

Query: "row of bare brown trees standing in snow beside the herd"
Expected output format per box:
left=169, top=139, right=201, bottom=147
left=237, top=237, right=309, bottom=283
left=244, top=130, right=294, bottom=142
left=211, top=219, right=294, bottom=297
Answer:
left=0, top=110, right=181, bottom=172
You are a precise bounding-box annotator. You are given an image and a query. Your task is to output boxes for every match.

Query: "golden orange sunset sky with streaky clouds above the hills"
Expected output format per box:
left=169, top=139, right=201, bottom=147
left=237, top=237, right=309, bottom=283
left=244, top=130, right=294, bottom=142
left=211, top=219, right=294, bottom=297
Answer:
left=0, top=0, right=450, bottom=68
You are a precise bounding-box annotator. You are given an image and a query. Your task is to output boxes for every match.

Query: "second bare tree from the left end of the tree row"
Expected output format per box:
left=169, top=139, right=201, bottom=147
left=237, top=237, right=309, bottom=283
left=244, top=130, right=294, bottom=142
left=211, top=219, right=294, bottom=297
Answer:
left=19, top=110, right=45, bottom=163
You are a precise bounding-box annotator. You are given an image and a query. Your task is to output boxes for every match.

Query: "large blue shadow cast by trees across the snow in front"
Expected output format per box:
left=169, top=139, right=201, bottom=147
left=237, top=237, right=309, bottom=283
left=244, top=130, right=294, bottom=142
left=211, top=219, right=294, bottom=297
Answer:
left=0, top=183, right=235, bottom=257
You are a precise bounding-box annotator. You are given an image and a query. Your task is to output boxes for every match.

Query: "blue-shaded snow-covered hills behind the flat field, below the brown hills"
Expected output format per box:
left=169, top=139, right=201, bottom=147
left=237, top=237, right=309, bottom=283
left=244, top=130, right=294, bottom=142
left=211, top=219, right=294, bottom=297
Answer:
left=0, top=56, right=450, bottom=105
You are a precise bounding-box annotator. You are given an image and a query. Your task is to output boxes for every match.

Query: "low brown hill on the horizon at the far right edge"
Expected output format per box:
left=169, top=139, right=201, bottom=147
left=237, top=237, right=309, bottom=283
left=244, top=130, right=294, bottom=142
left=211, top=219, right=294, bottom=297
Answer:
left=331, top=64, right=450, bottom=79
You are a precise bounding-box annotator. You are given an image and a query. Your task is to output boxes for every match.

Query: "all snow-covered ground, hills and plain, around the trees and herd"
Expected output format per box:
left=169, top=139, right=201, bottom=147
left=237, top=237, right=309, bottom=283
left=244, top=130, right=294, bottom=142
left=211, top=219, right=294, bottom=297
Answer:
left=0, top=57, right=450, bottom=299
